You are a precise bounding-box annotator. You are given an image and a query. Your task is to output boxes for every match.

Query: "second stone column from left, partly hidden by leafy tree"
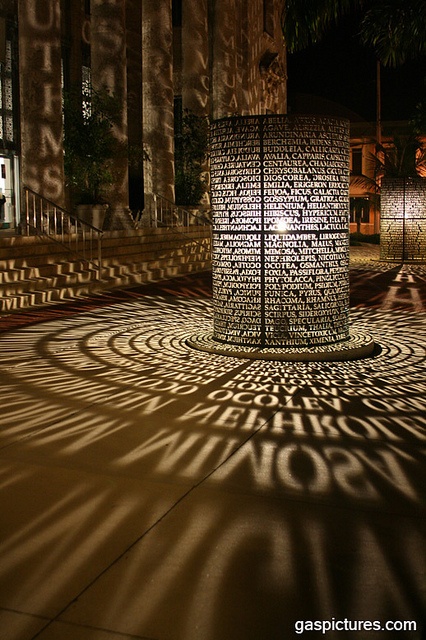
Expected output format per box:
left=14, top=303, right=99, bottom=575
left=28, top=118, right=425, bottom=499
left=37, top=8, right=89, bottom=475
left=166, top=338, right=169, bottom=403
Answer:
left=91, top=0, right=129, bottom=214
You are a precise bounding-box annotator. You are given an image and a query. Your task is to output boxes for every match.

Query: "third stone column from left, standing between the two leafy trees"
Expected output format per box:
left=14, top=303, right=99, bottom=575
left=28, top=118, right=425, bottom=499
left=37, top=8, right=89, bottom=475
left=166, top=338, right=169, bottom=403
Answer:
left=142, top=0, right=175, bottom=206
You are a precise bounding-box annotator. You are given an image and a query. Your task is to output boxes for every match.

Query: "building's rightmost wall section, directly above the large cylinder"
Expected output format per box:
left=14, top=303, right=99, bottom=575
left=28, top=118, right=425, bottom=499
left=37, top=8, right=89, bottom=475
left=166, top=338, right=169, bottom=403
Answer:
left=174, top=0, right=287, bottom=119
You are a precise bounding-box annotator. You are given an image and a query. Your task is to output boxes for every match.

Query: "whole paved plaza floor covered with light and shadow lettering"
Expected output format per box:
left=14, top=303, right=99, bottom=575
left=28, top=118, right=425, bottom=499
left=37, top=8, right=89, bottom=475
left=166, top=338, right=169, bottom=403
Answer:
left=0, top=246, right=426, bottom=640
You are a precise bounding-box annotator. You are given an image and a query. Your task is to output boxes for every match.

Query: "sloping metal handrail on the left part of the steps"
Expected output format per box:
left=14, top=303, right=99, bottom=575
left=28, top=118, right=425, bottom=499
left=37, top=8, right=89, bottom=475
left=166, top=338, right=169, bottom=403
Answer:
left=24, top=187, right=102, bottom=280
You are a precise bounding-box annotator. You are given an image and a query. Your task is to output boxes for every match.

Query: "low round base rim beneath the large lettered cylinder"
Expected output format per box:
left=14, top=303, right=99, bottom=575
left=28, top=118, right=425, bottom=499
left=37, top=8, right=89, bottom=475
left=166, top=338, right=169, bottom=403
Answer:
left=186, top=331, right=375, bottom=362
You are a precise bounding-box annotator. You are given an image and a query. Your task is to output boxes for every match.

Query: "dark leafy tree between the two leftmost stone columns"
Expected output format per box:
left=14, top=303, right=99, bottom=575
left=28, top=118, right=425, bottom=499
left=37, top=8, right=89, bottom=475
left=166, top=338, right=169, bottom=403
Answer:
left=64, top=90, right=121, bottom=204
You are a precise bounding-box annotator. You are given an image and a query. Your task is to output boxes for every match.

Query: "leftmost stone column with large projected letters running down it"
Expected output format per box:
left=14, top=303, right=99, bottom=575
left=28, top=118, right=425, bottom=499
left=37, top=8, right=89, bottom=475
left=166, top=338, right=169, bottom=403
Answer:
left=18, top=0, right=65, bottom=206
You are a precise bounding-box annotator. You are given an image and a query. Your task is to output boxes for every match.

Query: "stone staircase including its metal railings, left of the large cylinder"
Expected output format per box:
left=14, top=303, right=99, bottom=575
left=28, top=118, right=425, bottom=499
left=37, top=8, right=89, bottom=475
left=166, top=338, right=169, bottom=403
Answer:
left=0, top=189, right=211, bottom=314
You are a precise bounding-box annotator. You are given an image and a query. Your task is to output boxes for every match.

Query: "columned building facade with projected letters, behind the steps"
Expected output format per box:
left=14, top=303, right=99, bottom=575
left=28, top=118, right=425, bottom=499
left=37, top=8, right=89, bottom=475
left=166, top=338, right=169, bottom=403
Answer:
left=0, top=0, right=286, bottom=227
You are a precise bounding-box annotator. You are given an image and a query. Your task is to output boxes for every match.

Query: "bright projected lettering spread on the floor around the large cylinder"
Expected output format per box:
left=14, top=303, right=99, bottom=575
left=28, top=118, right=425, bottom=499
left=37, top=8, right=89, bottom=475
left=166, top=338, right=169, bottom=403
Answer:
left=2, top=299, right=426, bottom=502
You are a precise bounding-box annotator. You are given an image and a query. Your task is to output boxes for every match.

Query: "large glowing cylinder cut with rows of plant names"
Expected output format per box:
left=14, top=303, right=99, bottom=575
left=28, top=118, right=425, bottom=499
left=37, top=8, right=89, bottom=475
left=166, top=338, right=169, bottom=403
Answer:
left=211, top=115, right=349, bottom=347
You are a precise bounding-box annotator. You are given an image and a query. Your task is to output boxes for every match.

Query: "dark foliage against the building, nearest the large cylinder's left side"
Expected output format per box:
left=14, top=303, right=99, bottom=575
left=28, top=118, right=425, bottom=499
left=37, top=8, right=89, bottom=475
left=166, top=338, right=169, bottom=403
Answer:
left=175, top=109, right=209, bottom=206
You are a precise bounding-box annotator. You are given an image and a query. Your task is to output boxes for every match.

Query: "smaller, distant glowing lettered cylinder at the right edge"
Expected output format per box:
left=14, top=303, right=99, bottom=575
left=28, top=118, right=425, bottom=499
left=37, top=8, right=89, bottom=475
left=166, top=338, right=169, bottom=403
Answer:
left=380, top=178, right=426, bottom=262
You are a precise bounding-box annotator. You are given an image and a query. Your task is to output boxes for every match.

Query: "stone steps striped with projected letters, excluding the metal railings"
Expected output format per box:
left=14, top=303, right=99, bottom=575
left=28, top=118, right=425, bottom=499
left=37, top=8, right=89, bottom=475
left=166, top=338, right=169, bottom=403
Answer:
left=0, top=226, right=211, bottom=313
